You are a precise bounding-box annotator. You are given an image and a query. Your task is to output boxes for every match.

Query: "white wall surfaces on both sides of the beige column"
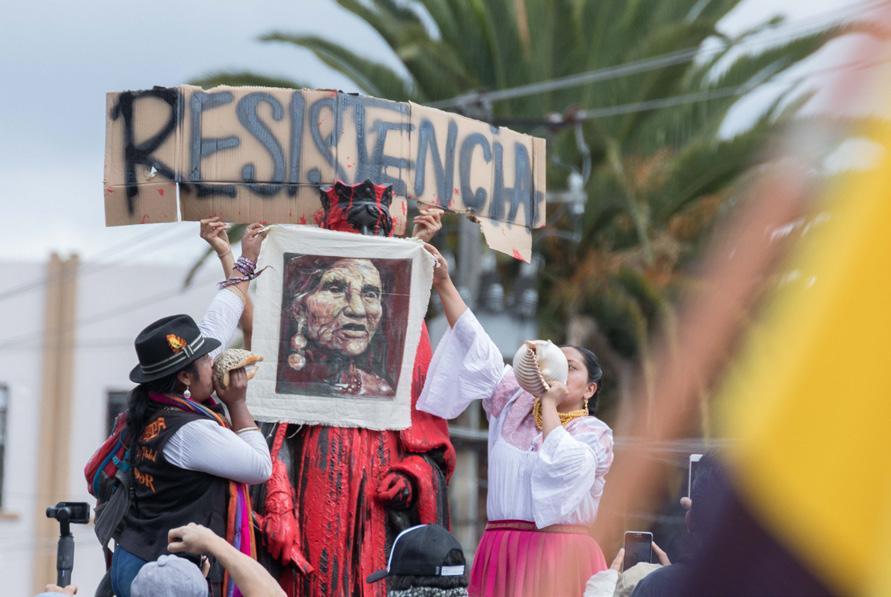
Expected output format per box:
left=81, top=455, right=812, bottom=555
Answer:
left=0, top=254, right=222, bottom=595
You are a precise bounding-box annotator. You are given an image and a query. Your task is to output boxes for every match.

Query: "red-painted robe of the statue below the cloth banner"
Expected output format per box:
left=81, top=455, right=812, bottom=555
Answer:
left=280, top=325, right=455, bottom=597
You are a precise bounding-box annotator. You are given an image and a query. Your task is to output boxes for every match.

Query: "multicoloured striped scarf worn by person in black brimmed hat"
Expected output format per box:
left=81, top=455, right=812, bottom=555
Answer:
left=149, top=393, right=257, bottom=597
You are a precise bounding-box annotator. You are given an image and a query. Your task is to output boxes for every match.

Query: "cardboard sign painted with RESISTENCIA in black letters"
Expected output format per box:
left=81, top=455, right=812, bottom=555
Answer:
left=104, top=85, right=546, bottom=259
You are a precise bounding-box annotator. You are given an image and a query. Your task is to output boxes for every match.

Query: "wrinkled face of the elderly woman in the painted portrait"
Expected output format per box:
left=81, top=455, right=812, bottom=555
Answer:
left=304, top=259, right=383, bottom=357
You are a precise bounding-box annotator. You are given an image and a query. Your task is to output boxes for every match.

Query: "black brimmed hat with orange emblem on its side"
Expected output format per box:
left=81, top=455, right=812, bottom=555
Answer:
left=130, top=315, right=220, bottom=383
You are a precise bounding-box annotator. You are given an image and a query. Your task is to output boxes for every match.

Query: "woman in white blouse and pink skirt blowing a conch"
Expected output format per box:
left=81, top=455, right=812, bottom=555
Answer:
left=418, top=245, right=613, bottom=596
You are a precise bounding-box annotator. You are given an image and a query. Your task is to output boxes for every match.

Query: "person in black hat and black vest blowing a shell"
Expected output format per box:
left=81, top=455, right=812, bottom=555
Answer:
left=111, top=220, right=272, bottom=597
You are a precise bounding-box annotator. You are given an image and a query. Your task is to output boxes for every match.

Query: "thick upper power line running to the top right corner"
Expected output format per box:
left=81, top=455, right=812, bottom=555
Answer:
left=429, top=0, right=888, bottom=108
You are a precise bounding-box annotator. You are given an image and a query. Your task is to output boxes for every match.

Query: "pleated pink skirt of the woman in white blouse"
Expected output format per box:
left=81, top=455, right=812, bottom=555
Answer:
left=468, top=520, right=607, bottom=597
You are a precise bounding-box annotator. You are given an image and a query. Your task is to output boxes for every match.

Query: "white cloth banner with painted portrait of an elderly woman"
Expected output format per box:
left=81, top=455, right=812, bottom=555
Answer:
left=247, top=226, right=434, bottom=429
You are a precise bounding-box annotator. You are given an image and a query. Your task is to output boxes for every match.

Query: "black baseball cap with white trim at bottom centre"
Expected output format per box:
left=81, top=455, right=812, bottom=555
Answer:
left=367, top=524, right=464, bottom=582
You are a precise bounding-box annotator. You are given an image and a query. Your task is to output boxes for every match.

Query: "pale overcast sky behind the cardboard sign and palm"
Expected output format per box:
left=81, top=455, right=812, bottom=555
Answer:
left=0, top=0, right=876, bottom=261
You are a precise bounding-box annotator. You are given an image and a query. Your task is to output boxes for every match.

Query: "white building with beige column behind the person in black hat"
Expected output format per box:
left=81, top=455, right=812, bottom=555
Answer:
left=0, top=253, right=222, bottom=596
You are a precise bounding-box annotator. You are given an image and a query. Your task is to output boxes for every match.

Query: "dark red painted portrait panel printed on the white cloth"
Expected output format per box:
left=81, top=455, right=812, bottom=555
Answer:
left=276, top=253, right=411, bottom=398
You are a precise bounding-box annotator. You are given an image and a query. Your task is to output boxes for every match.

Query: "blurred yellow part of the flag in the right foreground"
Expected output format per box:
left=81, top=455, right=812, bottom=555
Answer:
left=720, top=142, right=891, bottom=596
